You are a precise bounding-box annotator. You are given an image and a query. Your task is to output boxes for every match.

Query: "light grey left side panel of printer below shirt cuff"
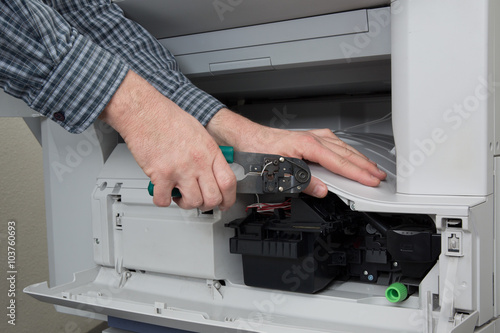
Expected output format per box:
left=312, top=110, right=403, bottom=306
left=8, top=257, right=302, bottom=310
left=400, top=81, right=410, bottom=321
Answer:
left=42, top=119, right=117, bottom=286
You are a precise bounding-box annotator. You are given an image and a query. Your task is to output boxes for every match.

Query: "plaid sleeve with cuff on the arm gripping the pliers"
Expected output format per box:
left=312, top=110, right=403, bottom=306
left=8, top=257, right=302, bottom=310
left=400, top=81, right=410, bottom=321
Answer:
left=0, top=0, right=128, bottom=133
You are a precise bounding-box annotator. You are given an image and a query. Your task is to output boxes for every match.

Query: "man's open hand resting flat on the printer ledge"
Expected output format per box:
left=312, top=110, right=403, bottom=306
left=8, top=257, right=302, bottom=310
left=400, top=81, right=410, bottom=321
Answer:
left=207, top=109, right=387, bottom=198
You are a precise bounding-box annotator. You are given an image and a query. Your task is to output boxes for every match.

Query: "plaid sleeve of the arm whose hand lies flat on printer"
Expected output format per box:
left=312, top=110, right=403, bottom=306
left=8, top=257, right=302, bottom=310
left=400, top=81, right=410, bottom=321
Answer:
left=43, top=0, right=225, bottom=125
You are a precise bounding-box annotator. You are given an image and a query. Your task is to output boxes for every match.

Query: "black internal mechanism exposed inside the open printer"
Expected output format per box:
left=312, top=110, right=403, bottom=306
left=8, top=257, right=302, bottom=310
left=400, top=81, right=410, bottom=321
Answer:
left=226, top=193, right=441, bottom=293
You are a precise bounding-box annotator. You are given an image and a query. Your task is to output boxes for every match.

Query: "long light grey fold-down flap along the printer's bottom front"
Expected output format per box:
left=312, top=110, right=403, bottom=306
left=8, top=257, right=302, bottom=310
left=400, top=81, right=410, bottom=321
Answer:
left=24, top=267, right=423, bottom=333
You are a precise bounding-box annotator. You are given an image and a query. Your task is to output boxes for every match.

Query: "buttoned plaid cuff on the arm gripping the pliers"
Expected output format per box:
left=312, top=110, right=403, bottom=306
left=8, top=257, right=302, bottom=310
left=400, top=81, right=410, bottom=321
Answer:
left=30, top=35, right=129, bottom=133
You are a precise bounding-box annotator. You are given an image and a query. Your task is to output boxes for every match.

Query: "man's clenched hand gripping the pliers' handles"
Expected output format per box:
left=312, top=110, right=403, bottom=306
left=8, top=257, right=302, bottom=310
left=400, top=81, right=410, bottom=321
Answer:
left=100, top=71, right=236, bottom=210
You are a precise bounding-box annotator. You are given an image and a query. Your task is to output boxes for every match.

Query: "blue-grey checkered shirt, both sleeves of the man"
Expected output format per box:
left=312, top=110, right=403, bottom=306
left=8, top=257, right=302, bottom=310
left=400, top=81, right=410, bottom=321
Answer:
left=0, top=0, right=224, bottom=133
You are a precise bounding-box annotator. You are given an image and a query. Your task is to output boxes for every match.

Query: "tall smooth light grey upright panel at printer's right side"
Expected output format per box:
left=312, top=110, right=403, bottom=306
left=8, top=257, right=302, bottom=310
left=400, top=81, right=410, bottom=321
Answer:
left=392, top=0, right=498, bottom=195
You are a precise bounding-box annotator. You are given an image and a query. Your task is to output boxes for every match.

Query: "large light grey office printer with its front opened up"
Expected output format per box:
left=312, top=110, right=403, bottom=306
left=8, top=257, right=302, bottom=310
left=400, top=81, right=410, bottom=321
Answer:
left=2, top=0, right=500, bottom=333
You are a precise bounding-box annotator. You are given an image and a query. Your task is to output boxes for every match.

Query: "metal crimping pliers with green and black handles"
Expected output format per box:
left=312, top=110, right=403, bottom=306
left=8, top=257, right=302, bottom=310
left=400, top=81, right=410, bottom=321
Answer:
left=148, top=146, right=311, bottom=197
